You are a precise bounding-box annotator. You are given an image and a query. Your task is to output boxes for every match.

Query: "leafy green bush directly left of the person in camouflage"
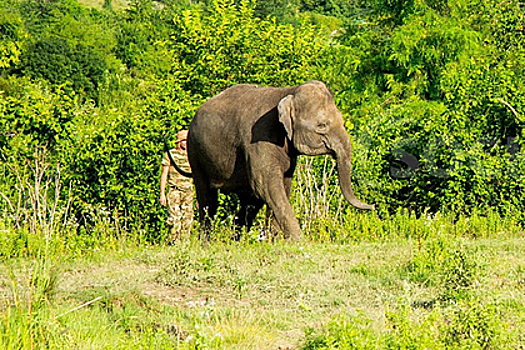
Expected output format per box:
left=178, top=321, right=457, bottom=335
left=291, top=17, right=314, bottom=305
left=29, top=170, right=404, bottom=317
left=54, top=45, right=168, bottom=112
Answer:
left=62, top=111, right=164, bottom=239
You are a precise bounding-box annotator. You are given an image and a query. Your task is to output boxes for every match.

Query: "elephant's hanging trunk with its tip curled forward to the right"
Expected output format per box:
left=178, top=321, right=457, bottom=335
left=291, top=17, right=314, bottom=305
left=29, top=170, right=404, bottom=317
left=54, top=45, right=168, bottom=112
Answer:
left=333, top=132, right=375, bottom=210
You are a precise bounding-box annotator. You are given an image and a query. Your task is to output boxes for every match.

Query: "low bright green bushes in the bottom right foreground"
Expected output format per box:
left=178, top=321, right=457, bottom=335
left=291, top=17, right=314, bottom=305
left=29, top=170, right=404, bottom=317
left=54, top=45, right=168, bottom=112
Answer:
left=303, top=300, right=519, bottom=350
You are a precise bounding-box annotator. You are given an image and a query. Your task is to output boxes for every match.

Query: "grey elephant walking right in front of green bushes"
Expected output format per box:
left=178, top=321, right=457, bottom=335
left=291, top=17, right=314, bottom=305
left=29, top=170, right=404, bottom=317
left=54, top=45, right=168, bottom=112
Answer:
left=176, top=81, right=374, bottom=240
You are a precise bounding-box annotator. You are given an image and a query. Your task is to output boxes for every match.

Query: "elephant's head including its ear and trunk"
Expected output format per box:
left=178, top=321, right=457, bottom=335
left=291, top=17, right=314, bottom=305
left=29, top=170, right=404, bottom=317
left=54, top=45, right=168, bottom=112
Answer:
left=278, top=81, right=374, bottom=210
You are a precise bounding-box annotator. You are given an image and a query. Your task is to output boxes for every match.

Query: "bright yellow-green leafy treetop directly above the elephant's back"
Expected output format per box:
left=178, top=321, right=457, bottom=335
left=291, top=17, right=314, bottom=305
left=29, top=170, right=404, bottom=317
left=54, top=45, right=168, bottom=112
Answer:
left=168, top=0, right=322, bottom=97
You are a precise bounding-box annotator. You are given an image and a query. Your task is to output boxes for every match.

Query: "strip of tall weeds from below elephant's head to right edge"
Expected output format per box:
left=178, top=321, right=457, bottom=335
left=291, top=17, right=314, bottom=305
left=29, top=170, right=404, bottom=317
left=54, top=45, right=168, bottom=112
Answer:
left=291, top=156, right=523, bottom=243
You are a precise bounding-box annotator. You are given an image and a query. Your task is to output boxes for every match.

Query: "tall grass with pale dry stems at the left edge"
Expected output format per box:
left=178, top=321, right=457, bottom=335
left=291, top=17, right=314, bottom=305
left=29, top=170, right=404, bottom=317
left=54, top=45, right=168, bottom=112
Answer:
left=0, top=148, right=135, bottom=258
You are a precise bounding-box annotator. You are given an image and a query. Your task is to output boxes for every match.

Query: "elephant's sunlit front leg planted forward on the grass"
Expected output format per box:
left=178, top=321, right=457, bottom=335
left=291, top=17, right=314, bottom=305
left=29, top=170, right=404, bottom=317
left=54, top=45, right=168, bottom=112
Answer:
left=255, top=172, right=301, bottom=241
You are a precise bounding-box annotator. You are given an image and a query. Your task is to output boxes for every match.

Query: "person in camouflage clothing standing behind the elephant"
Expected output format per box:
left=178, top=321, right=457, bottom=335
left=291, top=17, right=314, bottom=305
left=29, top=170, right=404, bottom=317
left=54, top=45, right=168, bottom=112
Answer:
left=160, top=130, right=193, bottom=243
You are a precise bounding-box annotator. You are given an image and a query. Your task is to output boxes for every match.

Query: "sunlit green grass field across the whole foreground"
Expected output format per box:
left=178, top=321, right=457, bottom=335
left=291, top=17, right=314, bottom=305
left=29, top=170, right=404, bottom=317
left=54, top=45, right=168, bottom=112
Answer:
left=0, top=214, right=525, bottom=349
